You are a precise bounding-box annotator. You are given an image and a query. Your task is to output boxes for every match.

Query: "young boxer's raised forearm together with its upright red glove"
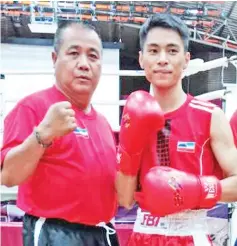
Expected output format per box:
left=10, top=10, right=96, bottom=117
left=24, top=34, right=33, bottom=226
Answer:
left=115, top=91, right=165, bottom=209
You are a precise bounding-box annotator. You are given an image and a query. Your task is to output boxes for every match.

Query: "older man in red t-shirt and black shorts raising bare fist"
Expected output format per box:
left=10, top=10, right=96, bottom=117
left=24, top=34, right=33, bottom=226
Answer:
left=1, top=21, right=118, bottom=246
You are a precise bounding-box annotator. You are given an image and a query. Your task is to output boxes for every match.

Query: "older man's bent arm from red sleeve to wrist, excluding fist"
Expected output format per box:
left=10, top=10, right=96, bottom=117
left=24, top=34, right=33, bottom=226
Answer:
left=1, top=103, right=44, bottom=187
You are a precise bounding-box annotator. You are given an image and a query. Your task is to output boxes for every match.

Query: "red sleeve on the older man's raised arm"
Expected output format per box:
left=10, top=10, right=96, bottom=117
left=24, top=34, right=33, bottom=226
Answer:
left=1, top=104, right=38, bottom=165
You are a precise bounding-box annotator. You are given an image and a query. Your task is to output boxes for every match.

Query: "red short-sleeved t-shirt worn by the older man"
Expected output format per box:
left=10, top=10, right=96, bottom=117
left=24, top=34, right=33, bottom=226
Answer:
left=1, top=86, right=117, bottom=225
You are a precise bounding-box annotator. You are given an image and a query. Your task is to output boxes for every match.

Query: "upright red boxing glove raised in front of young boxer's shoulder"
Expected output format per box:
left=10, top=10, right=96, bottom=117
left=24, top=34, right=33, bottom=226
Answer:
left=117, top=91, right=165, bottom=176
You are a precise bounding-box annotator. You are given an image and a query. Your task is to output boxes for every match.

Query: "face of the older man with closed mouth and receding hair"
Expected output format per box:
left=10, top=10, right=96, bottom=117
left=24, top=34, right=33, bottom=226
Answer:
left=52, top=25, right=102, bottom=97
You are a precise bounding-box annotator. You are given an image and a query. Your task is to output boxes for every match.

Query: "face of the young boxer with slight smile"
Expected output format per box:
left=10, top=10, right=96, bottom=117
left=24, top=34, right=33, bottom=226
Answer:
left=139, top=27, right=190, bottom=89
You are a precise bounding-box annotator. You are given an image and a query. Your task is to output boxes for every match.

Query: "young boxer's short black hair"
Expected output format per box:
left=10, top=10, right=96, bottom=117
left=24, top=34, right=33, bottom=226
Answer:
left=139, top=13, right=189, bottom=51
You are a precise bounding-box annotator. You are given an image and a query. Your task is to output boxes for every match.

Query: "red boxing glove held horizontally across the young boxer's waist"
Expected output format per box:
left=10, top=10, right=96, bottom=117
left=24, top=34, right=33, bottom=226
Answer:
left=135, top=166, right=221, bottom=216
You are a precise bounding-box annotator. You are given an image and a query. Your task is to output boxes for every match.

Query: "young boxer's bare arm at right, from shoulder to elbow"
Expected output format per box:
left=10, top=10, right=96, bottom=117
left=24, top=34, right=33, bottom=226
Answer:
left=211, top=108, right=237, bottom=202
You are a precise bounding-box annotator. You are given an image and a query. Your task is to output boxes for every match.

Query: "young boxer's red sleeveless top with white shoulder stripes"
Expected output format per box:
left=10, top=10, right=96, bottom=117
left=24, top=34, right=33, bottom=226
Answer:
left=140, top=95, right=223, bottom=187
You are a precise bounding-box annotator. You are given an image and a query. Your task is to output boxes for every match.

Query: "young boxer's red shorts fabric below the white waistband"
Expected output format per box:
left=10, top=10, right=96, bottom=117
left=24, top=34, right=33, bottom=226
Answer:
left=127, top=232, right=212, bottom=246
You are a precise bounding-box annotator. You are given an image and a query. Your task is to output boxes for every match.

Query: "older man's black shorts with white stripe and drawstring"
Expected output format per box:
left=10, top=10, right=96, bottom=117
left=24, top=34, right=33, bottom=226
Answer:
left=23, top=214, right=119, bottom=246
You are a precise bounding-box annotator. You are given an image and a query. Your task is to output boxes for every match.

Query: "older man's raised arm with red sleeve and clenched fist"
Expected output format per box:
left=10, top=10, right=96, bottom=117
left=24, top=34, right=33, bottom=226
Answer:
left=1, top=102, right=77, bottom=186
